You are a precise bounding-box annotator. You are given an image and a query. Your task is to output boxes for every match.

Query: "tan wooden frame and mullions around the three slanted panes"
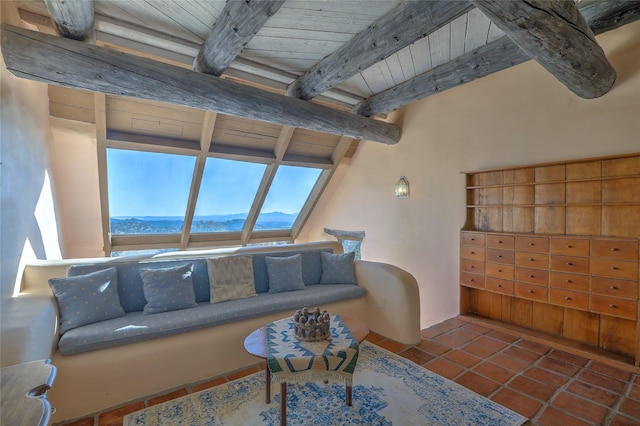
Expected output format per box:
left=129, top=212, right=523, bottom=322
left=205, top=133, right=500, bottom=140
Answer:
left=96, top=113, right=353, bottom=257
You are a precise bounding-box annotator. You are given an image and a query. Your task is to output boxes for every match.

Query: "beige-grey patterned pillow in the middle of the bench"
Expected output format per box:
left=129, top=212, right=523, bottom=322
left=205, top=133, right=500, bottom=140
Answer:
left=207, top=256, right=256, bottom=303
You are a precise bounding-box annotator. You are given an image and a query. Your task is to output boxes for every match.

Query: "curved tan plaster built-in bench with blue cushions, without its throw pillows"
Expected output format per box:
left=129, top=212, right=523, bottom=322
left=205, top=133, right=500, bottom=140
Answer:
left=2, top=242, right=420, bottom=422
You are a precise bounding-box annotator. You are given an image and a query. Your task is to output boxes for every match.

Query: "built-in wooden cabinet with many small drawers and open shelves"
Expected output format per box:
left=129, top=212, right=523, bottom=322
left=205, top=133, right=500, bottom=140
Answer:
left=460, top=154, right=640, bottom=365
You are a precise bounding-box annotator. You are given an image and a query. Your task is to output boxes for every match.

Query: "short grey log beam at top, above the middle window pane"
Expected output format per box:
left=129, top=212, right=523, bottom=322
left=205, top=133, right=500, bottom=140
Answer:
left=193, top=0, right=284, bottom=77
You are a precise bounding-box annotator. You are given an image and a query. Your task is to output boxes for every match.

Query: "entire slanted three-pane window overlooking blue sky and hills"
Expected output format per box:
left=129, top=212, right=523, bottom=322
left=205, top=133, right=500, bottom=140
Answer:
left=106, top=146, right=323, bottom=255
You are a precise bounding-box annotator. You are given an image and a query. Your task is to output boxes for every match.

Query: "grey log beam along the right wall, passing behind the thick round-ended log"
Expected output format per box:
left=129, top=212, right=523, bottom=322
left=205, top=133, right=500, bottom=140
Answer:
left=353, top=0, right=640, bottom=117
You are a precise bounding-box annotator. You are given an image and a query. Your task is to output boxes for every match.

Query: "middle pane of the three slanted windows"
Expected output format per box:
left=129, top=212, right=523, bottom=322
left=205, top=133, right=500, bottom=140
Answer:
left=191, top=158, right=267, bottom=232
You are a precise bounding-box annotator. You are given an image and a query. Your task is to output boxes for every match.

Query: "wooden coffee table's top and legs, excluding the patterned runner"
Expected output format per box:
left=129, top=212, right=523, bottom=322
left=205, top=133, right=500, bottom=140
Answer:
left=244, top=316, right=369, bottom=426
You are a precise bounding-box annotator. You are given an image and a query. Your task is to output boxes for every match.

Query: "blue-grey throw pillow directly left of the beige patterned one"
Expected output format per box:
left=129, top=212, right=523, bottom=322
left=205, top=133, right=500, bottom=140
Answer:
left=140, top=263, right=198, bottom=314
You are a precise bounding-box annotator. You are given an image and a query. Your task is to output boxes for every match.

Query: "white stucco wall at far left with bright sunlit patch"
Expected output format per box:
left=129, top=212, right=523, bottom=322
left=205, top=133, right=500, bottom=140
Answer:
left=0, top=2, right=61, bottom=304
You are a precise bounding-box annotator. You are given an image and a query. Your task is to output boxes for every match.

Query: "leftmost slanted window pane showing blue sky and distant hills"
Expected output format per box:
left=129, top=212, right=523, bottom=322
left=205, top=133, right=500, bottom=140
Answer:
left=107, top=148, right=195, bottom=235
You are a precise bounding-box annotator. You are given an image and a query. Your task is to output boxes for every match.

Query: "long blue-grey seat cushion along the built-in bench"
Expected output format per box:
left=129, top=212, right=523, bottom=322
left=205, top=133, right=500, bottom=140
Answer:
left=58, top=284, right=366, bottom=355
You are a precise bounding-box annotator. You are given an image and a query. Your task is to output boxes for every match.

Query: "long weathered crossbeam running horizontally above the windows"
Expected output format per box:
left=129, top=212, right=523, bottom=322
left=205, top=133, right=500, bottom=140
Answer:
left=2, top=24, right=400, bottom=144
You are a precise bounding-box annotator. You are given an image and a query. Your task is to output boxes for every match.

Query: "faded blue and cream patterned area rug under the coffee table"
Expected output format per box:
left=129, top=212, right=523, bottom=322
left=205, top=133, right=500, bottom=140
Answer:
left=124, top=342, right=527, bottom=426
